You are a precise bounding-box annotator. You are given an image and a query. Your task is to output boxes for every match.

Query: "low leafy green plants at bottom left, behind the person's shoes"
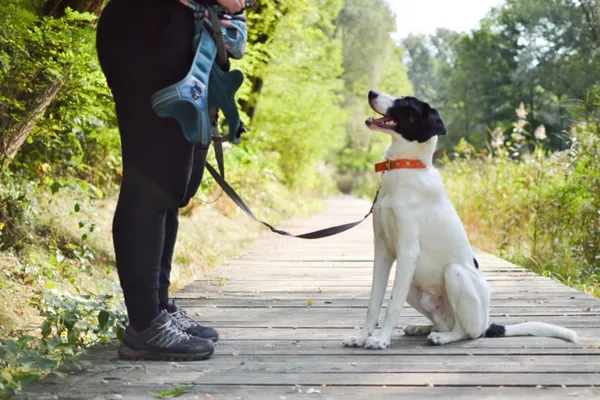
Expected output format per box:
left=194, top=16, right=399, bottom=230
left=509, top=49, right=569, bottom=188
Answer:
left=0, top=291, right=125, bottom=396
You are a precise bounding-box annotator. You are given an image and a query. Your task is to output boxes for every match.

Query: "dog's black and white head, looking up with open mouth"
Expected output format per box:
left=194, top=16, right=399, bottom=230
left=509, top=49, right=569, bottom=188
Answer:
left=366, top=90, right=447, bottom=143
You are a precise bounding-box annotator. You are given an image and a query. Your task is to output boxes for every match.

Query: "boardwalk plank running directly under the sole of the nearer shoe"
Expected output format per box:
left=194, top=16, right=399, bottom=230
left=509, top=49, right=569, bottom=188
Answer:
left=76, top=349, right=600, bottom=374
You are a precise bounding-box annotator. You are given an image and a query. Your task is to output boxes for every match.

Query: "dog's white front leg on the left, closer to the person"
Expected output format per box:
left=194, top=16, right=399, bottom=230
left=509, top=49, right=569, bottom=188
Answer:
left=343, top=240, right=394, bottom=347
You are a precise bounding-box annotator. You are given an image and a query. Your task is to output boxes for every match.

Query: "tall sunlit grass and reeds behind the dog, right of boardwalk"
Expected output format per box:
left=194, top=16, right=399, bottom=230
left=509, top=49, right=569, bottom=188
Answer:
left=442, top=91, right=600, bottom=295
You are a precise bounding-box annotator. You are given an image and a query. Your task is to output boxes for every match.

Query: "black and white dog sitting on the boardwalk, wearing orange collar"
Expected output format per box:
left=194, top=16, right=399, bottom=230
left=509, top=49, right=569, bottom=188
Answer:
left=343, top=91, right=577, bottom=349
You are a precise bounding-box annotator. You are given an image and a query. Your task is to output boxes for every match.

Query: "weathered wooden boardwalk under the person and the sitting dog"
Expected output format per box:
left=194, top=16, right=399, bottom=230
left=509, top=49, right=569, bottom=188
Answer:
left=22, top=197, right=600, bottom=400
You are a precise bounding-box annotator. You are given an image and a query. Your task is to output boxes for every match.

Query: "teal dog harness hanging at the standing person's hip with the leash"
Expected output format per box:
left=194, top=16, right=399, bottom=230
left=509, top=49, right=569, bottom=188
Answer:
left=151, top=0, right=247, bottom=145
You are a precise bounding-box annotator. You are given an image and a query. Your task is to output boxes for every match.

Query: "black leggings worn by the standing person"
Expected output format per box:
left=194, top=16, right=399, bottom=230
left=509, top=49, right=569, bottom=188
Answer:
left=97, top=0, right=208, bottom=331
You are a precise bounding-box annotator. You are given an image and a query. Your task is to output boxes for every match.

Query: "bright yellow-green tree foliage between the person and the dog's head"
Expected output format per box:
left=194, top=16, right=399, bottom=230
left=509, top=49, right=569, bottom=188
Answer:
left=251, top=0, right=345, bottom=190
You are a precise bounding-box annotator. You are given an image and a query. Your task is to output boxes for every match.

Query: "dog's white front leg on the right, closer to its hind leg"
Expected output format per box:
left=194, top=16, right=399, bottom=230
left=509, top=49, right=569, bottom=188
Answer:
left=365, top=240, right=419, bottom=350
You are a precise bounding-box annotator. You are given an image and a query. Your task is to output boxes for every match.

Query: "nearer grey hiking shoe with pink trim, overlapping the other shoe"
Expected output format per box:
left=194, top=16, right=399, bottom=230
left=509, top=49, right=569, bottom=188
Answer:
left=119, top=310, right=215, bottom=361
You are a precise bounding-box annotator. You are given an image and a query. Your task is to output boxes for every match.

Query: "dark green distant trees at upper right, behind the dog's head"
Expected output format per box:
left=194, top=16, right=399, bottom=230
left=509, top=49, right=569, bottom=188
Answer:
left=403, top=0, right=600, bottom=150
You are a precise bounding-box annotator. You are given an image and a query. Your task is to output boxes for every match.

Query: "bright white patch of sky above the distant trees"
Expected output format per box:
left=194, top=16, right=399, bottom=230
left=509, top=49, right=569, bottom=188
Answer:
left=387, top=0, right=502, bottom=39
